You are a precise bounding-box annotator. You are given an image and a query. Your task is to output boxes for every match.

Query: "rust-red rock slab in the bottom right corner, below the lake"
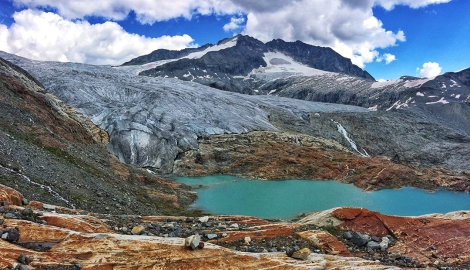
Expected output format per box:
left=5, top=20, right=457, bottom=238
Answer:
left=300, top=208, right=470, bottom=266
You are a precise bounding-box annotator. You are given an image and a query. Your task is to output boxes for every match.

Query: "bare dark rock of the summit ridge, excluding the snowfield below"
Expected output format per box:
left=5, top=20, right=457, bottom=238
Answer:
left=123, top=35, right=374, bottom=80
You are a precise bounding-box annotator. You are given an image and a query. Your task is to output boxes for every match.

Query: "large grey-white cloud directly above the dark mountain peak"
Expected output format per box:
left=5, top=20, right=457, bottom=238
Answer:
left=244, top=0, right=406, bottom=67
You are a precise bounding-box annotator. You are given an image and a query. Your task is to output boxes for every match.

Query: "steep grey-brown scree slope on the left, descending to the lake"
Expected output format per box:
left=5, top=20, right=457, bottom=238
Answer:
left=0, top=58, right=195, bottom=216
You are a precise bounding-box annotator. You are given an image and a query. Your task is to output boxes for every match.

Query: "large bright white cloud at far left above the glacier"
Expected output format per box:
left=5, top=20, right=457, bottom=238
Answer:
left=0, top=10, right=193, bottom=65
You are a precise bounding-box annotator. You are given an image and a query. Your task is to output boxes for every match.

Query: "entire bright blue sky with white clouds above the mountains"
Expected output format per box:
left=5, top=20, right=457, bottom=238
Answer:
left=0, top=0, right=470, bottom=80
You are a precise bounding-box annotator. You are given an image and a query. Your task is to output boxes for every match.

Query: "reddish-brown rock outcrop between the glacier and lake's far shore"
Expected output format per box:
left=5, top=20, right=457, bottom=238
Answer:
left=173, top=131, right=470, bottom=191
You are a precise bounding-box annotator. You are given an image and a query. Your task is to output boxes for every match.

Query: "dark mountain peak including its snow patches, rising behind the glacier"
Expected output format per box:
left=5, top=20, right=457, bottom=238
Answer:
left=124, top=35, right=374, bottom=94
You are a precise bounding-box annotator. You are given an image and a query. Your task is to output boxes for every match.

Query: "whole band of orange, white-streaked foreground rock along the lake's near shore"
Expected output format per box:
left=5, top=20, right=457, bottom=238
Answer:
left=0, top=187, right=470, bottom=269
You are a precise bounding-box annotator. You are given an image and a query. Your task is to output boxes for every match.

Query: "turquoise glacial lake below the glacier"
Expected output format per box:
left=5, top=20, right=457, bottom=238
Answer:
left=175, top=175, right=470, bottom=219
